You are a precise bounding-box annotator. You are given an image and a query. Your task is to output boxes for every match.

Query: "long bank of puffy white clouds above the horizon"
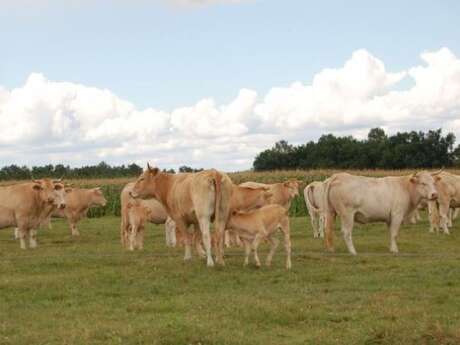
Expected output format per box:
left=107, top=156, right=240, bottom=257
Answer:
left=0, top=48, right=460, bottom=171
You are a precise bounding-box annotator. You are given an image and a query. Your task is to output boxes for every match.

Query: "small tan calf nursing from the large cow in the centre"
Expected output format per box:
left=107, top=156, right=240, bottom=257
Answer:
left=227, top=205, right=291, bottom=269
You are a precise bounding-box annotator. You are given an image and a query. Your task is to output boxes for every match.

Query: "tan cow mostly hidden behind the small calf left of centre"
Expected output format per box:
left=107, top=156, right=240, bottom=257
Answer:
left=120, top=182, right=176, bottom=247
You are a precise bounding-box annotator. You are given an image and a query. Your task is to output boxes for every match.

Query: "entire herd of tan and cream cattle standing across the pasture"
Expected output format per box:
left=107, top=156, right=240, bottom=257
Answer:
left=0, top=165, right=460, bottom=269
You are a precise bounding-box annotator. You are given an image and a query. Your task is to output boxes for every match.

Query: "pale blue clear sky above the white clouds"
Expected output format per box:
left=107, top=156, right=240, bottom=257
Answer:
left=0, top=0, right=460, bottom=168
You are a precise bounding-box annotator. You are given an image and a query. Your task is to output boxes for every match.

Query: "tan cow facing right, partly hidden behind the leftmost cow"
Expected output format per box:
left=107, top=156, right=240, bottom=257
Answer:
left=48, top=187, right=107, bottom=236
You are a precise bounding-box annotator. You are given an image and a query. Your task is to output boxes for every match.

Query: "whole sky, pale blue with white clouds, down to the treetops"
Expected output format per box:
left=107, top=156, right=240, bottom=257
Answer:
left=0, top=0, right=460, bottom=171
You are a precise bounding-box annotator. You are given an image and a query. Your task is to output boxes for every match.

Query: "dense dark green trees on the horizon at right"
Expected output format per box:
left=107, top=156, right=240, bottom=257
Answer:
left=253, top=128, right=460, bottom=171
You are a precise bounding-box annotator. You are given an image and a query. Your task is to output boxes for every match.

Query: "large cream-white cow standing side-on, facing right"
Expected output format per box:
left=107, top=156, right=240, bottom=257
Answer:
left=324, top=171, right=439, bottom=255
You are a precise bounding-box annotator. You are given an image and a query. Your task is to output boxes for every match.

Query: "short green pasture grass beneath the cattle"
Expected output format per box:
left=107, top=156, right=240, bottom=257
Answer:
left=0, top=216, right=460, bottom=345
